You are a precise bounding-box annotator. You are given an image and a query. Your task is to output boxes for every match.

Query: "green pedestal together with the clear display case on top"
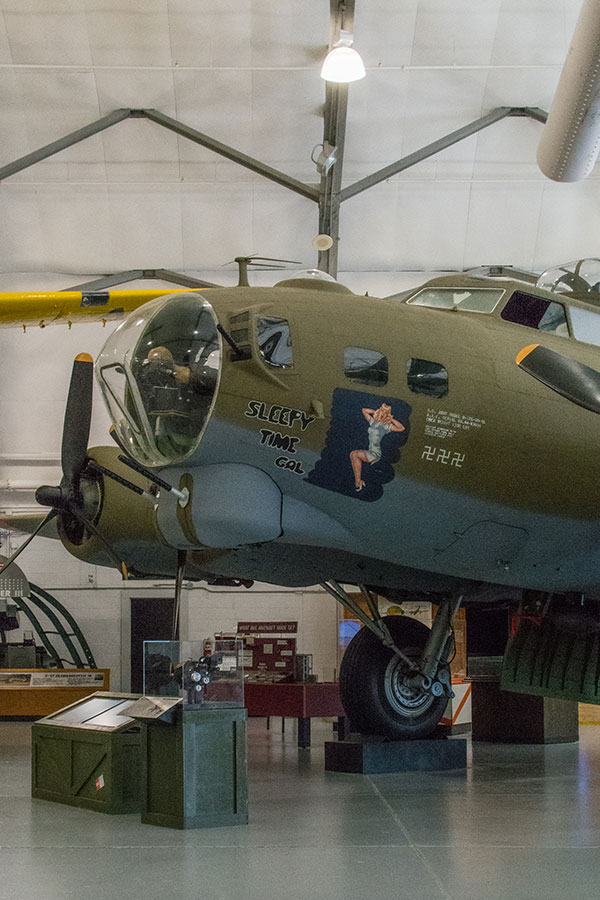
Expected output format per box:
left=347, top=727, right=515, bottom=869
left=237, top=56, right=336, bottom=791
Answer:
left=137, top=641, right=248, bottom=828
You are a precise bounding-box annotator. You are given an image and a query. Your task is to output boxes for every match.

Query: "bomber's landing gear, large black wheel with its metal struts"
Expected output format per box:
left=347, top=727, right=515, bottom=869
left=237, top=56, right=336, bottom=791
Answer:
left=322, top=581, right=462, bottom=740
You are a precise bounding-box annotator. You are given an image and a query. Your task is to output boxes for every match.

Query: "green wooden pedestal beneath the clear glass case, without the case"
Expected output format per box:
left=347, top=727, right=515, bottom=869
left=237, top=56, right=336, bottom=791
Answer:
left=140, top=707, right=248, bottom=828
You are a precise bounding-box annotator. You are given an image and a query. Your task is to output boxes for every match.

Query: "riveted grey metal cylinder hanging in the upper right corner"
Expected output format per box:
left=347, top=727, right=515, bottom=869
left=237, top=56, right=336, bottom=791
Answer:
left=537, top=0, right=600, bottom=182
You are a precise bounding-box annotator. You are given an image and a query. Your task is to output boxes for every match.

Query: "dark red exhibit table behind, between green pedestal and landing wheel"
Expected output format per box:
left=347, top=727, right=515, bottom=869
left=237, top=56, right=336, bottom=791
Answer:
left=244, top=681, right=346, bottom=749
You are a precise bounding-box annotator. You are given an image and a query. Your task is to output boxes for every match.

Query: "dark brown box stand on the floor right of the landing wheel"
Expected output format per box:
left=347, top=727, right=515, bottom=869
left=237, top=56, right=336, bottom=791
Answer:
left=471, top=675, right=579, bottom=744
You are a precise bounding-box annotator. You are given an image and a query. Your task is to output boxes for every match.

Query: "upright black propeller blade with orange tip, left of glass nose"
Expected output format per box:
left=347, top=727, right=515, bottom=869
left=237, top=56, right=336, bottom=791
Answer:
left=61, top=353, right=94, bottom=491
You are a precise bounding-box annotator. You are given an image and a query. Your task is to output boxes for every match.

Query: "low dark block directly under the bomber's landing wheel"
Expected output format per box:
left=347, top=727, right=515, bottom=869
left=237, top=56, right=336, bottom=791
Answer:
left=325, top=735, right=467, bottom=775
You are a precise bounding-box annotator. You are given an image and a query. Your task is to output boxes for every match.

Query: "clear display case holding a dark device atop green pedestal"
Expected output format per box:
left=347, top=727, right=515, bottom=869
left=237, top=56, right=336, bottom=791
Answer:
left=144, top=638, right=244, bottom=709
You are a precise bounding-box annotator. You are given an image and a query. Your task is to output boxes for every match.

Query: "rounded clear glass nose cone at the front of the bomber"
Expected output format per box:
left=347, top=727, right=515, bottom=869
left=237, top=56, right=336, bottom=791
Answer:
left=96, top=293, right=222, bottom=466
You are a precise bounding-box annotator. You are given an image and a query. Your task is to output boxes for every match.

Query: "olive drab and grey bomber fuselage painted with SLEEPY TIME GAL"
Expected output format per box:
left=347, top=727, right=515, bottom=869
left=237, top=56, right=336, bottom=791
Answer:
left=5, top=275, right=600, bottom=592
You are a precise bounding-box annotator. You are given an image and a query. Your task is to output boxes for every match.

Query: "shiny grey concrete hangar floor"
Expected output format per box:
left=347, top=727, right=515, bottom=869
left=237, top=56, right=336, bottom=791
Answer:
left=0, top=719, right=600, bottom=900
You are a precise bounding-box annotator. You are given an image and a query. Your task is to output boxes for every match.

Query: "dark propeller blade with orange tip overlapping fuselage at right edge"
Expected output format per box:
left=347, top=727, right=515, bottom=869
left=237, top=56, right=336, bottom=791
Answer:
left=516, top=344, right=600, bottom=413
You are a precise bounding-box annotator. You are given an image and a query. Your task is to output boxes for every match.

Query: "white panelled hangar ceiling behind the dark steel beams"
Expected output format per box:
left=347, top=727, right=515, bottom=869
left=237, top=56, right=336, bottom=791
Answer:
left=0, top=0, right=600, bottom=275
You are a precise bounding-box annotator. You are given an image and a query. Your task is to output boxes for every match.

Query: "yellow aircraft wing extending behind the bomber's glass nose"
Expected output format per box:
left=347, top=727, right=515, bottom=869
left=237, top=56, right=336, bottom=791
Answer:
left=0, top=288, right=196, bottom=329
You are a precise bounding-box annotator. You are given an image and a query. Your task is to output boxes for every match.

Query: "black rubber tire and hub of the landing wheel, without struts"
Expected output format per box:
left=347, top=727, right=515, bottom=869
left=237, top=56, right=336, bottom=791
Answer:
left=340, top=616, right=448, bottom=740
